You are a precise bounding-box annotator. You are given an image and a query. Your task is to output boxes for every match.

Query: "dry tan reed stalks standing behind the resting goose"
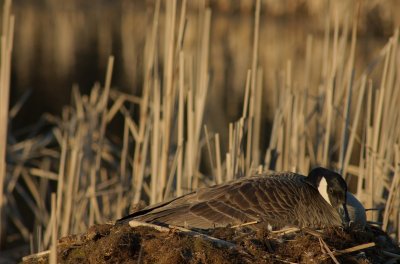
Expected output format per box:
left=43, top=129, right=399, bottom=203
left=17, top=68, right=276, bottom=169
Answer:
left=0, top=1, right=400, bottom=261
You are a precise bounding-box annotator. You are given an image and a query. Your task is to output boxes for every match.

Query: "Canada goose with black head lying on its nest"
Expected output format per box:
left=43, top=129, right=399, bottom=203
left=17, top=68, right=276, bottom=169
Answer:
left=117, top=167, right=350, bottom=229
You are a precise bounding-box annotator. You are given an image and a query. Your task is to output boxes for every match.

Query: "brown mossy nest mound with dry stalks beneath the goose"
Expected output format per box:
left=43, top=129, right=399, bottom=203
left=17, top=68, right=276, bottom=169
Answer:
left=23, top=221, right=400, bottom=263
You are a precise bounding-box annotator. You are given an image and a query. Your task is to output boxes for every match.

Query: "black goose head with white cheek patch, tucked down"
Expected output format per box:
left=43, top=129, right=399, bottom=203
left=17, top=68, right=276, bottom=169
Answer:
left=307, top=167, right=350, bottom=227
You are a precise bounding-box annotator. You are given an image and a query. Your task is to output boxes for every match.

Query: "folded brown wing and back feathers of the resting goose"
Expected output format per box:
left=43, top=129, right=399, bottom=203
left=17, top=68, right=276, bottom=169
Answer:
left=119, top=174, right=304, bottom=228
